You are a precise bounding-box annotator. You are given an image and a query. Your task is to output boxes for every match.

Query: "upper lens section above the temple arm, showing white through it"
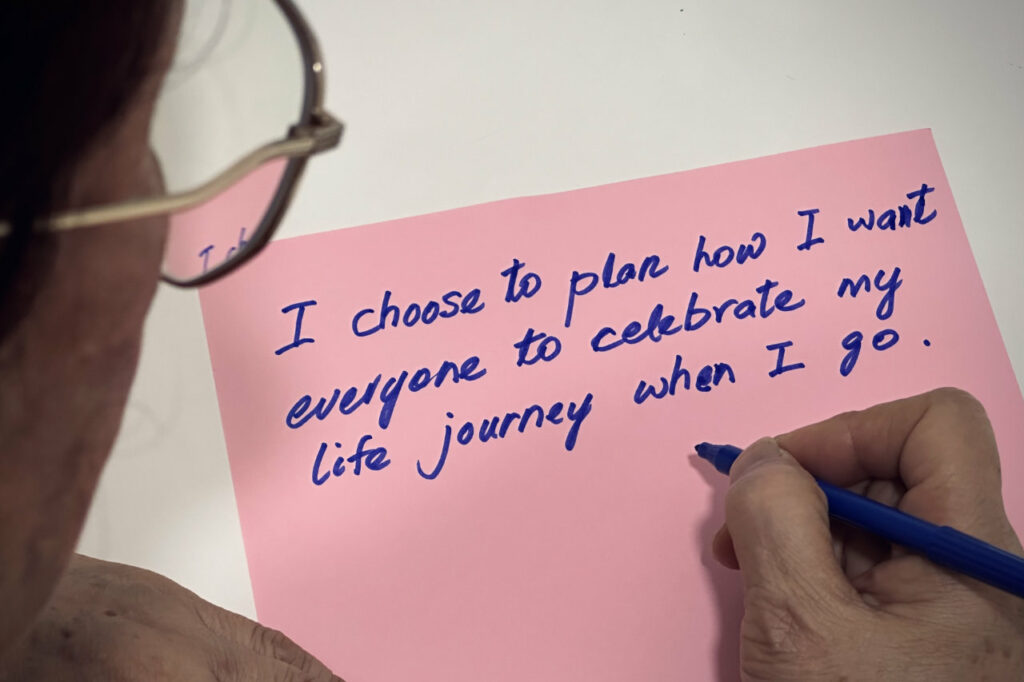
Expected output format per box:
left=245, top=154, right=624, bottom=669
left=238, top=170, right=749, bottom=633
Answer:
left=151, top=0, right=304, bottom=194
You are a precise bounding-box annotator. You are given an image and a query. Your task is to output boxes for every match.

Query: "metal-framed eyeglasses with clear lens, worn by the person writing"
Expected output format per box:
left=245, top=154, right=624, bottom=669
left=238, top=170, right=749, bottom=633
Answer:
left=19, top=0, right=344, bottom=287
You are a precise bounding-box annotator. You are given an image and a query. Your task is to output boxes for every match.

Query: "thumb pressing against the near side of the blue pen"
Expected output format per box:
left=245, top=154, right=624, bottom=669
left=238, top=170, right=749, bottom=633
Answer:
left=725, top=438, right=856, bottom=610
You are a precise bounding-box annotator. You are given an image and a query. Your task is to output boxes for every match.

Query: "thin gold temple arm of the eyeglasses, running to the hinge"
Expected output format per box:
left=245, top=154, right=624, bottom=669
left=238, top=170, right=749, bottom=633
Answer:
left=0, top=111, right=343, bottom=238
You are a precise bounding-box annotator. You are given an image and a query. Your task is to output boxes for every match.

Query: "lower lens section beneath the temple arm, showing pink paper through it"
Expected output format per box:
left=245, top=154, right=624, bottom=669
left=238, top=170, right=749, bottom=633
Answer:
left=163, top=159, right=288, bottom=284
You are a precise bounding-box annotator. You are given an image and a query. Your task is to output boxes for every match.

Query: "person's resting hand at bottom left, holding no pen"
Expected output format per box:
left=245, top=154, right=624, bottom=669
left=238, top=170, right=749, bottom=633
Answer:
left=0, top=555, right=341, bottom=682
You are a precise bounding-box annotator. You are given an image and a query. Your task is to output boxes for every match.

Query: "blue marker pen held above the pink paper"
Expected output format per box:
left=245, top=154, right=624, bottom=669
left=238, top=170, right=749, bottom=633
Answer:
left=696, top=442, right=1024, bottom=597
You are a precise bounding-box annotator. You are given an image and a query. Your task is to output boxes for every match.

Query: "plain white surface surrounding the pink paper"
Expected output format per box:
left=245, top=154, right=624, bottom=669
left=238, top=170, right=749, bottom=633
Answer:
left=80, top=0, right=1024, bottom=616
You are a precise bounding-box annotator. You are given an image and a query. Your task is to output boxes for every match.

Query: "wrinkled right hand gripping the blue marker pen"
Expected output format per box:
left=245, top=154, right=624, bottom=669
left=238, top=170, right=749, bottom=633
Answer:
left=714, top=389, right=1024, bottom=682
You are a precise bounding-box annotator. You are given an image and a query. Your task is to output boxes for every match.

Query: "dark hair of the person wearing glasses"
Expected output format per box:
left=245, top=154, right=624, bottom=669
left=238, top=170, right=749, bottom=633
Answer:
left=0, top=0, right=175, bottom=339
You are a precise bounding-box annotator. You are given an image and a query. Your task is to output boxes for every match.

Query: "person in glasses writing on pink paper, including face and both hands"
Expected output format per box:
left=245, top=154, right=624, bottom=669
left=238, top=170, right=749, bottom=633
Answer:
left=0, top=0, right=1024, bottom=681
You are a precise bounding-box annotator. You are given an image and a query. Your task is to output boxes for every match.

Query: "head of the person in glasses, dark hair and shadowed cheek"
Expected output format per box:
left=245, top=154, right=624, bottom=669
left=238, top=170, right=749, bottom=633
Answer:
left=0, top=0, right=181, bottom=655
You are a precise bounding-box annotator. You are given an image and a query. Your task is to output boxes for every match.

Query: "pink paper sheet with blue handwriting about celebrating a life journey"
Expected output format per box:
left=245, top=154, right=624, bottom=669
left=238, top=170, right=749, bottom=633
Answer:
left=202, top=130, right=1024, bottom=682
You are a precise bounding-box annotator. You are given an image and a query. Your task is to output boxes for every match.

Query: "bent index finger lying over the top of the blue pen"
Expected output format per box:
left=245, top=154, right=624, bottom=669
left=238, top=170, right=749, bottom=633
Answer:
left=777, top=388, right=1020, bottom=549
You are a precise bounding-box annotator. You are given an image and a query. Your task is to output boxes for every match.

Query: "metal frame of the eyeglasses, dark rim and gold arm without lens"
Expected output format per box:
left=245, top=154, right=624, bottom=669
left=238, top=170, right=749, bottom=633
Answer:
left=6, top=0, right=344, bottom=288
